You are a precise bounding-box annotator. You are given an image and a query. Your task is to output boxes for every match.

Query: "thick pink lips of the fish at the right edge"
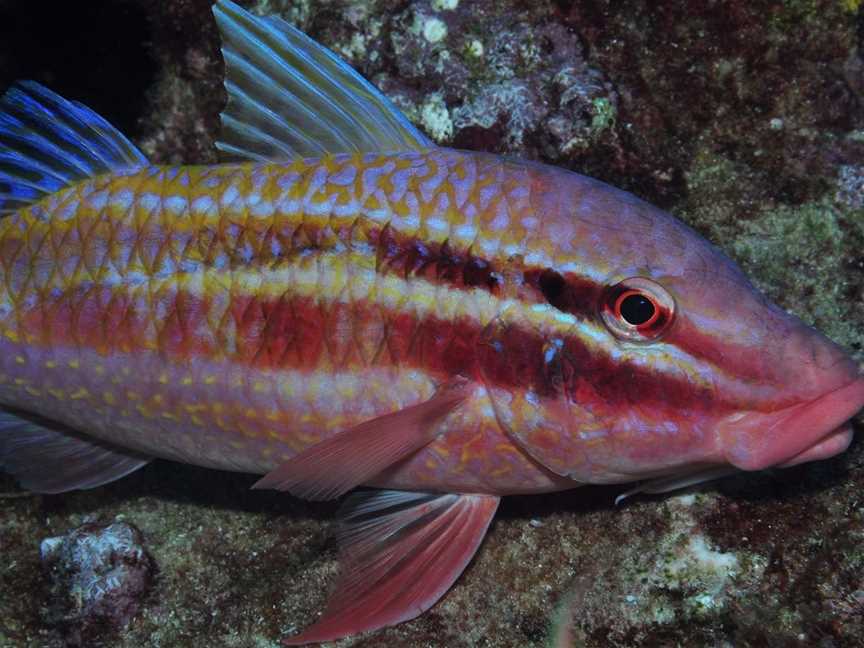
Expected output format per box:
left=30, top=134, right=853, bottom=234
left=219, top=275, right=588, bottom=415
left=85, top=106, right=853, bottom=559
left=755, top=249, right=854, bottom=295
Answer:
left=719, top=375, right=864, bottom=470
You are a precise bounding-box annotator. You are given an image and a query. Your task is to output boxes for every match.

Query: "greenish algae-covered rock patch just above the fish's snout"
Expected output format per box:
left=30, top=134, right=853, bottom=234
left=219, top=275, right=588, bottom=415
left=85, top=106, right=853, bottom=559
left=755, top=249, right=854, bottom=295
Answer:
left=679, top=147, right=864, bottom=361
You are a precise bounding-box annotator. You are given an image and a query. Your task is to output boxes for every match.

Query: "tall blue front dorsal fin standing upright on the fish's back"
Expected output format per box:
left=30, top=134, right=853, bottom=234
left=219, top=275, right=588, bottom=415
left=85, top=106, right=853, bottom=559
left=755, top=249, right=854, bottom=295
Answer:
left=213, top=0, right=434, bottom=161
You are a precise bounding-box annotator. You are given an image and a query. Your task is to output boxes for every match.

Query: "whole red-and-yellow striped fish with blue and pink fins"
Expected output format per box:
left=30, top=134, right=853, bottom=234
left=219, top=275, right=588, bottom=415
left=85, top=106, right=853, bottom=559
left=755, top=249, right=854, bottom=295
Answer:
left=0, top=0, right=864, bottom=645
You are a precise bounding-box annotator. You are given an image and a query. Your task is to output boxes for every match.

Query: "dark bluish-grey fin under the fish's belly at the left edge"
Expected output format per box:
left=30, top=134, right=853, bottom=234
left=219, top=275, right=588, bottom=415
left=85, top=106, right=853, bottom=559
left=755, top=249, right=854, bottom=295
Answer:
left=0, top=412, right=150, bottom=493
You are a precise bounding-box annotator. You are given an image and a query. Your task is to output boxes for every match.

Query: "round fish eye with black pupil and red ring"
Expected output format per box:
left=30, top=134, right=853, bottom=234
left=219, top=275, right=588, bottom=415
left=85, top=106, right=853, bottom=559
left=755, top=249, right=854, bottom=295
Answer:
left=601, top=277, right=675, bottom=341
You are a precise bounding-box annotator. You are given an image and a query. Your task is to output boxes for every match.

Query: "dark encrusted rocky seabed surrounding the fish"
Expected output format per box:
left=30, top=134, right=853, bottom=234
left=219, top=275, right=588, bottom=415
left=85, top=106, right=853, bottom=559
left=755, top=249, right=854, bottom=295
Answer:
left=0, top=0, right=864, bottom=648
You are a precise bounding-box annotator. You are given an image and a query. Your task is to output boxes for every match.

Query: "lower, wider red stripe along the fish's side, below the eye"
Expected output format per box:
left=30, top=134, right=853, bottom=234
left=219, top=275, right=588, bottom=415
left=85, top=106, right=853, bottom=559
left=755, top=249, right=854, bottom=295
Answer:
left=23, top=288, right=717, bottom=410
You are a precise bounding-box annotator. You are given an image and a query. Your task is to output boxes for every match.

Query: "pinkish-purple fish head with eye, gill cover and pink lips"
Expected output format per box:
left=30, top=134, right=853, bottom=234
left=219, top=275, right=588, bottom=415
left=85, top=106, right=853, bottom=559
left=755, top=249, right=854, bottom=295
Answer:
left=489, top=165, right=864, bottom=483
